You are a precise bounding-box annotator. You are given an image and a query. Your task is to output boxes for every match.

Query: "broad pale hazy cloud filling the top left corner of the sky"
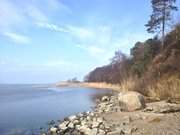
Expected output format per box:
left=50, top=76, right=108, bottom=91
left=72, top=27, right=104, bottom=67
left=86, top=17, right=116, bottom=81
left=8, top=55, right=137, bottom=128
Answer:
left=0, top=0, right=71, bottom=33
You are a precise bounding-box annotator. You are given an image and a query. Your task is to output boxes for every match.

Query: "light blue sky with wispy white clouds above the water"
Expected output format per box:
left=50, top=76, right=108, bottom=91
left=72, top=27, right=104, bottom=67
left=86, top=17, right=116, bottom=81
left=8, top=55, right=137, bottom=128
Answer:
left=0, top=0, right=180, bottom=83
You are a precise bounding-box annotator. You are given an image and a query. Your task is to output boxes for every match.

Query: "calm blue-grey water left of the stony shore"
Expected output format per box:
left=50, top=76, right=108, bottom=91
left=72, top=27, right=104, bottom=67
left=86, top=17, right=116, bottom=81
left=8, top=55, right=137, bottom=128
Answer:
left=0, top=85, right=112, bottom=135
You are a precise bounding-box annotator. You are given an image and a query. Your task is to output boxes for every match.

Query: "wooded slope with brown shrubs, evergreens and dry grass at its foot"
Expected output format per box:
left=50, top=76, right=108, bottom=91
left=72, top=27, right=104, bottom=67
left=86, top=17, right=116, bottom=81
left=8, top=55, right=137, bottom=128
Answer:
left=85, top=24, right=180, bottom=98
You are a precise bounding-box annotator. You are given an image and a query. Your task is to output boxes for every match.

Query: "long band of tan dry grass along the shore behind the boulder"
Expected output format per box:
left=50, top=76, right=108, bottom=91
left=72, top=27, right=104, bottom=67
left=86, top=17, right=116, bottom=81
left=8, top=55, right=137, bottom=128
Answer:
left=56, top=74, right=180, bottom=99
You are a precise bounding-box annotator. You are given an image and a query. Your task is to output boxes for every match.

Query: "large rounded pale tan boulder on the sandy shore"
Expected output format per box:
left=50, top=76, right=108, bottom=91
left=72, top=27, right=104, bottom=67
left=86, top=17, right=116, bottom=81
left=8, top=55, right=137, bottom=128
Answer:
left=118, top=91, right=145, bottom=111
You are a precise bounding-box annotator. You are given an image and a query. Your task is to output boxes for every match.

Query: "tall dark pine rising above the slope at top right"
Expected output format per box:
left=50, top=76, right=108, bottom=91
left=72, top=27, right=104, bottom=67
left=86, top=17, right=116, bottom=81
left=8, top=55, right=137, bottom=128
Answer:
left=145, top=0, right=177, bottom=47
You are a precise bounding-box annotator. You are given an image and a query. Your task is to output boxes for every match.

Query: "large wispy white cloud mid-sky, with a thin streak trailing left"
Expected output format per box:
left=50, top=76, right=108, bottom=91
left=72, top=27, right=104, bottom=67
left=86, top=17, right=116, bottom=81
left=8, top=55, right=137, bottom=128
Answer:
left=33, top=19, right=149, bottom=61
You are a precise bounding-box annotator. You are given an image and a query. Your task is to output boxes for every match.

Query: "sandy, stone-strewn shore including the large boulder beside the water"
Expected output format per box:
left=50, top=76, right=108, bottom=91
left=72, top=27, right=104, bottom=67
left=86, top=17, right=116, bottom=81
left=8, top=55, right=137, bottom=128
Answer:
left=43, top=92, right=180, bottom=135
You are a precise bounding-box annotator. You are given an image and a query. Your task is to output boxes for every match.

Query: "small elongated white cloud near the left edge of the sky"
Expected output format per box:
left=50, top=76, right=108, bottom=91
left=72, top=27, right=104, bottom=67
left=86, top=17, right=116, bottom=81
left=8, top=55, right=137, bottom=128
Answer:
left=4, top=32, right=31, bottom=44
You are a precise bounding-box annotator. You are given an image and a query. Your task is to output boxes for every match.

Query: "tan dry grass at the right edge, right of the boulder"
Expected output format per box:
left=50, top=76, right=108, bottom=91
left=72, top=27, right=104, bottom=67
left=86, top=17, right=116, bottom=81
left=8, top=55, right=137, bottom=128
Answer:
left=147, top=75, right=180, bottom=99
